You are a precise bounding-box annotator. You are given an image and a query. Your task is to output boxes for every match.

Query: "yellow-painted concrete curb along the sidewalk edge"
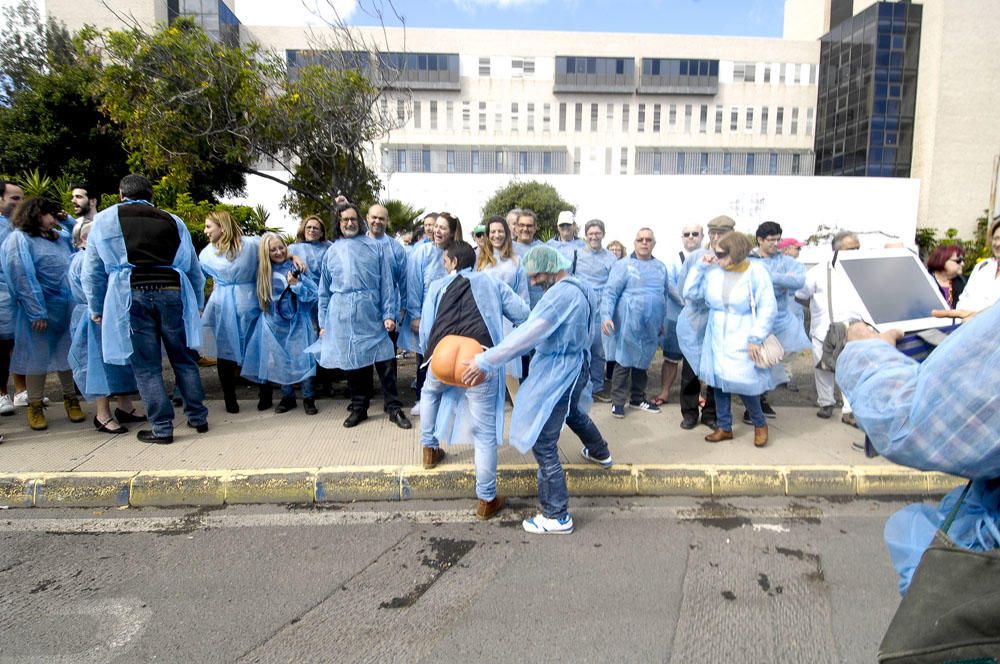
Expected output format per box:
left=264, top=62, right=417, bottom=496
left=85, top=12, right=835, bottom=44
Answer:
left=0, top=464, right=964, bottom=507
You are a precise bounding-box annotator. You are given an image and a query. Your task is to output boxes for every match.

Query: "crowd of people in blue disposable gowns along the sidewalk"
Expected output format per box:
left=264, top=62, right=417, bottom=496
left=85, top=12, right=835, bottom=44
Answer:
left=0, top=175, right=1000, bottom=533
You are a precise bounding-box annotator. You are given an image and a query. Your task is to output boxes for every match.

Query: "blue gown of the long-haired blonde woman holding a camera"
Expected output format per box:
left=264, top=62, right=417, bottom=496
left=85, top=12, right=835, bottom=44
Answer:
left=241, top=260, right=317, bottom=385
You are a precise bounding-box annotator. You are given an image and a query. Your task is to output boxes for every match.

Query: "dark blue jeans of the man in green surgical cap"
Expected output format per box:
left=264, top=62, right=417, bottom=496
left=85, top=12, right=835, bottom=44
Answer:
left=531, top=361, right=611, bottom=519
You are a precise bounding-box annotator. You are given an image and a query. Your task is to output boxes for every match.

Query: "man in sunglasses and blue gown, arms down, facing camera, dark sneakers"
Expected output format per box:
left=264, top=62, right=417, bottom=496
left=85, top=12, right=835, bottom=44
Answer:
left=601, top=228, right=667, bottom=418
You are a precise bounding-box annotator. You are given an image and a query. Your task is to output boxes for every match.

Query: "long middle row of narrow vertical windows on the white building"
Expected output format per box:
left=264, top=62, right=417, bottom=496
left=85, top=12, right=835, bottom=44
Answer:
left=382, top=98, right=815, bottom=136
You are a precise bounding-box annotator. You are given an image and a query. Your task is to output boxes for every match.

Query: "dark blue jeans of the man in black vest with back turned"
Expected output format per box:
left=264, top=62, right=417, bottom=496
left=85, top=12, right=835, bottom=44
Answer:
left=129, top=289, right=208, bottom=436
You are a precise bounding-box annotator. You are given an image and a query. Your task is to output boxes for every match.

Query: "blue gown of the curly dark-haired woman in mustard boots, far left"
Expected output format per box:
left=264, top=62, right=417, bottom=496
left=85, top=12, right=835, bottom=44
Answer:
left=0, top=230, right=73, bottom=376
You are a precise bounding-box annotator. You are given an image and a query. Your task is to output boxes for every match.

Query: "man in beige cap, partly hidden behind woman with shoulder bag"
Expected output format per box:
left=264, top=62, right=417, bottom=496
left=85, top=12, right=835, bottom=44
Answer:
left=677, top=214, right=736, bottom=429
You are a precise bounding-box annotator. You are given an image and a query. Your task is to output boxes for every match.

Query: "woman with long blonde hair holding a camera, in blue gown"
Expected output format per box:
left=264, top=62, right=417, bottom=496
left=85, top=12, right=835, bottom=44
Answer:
left=242, top=233, right=318, bottom=415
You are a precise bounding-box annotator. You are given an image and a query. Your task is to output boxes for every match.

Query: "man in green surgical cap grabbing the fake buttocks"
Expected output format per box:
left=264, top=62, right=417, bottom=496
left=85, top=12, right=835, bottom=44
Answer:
left=462, top=247, right=612, bottom=535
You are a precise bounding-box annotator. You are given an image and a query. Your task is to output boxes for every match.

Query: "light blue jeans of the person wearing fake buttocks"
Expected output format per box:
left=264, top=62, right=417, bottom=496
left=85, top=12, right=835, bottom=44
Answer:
left=420, top=372, right=502, bottom=500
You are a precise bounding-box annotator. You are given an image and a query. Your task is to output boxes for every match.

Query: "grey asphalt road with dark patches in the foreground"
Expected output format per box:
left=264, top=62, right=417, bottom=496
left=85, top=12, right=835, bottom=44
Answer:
left=0, top=498, right=901, bottom=664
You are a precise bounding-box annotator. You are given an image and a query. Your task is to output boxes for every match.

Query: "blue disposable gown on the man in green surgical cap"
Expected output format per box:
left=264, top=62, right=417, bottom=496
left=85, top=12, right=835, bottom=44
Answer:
left=476, top=277, right=598, bottom=453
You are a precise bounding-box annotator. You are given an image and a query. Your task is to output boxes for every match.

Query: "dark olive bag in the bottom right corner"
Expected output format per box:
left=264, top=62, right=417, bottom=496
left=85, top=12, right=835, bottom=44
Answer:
left=878, top=481, right=1000, bottom=664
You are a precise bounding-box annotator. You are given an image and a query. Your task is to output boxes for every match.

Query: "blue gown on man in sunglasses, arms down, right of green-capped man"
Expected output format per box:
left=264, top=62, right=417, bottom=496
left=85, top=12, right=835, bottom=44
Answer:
left=601, top=257, right=667, bottom=369
